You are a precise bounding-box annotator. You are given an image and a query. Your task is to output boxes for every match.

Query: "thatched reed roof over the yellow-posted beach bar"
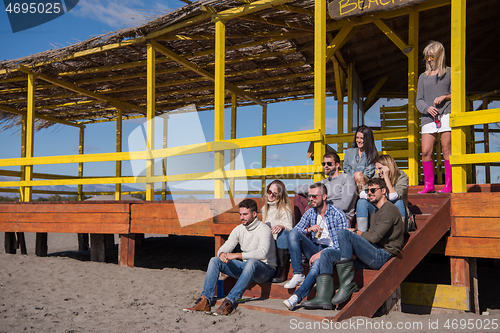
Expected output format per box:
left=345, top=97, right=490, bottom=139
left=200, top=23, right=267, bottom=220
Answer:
left=0, top=0, right=500, bottom=128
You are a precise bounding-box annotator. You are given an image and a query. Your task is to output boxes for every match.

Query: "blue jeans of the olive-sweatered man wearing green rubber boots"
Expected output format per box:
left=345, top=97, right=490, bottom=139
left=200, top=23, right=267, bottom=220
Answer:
left=338, top=229, right=392, bottom=269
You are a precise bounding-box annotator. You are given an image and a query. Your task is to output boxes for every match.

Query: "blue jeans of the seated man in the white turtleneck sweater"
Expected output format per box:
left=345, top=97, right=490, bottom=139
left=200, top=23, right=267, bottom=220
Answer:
left=201, top=257, right=274, bottom=304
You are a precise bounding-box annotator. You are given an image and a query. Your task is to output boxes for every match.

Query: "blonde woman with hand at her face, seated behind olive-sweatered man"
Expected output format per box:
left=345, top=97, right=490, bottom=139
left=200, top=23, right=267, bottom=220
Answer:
left=356, top=155, right=409, bottom=231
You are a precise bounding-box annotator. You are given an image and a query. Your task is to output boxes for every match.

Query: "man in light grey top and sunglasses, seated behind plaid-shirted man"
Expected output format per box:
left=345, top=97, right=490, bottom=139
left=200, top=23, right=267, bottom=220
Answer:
left=294, top=152, right=358, bottom=222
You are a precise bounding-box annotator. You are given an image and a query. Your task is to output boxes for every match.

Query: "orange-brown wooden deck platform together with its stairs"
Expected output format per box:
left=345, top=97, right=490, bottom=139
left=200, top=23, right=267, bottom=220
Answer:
left=0, top=185, right=500, bottom=320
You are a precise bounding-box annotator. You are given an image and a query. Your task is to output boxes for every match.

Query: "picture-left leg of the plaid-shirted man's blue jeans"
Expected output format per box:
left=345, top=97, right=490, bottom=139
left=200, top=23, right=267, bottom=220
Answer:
left=288, top=229, right=327, bottom=274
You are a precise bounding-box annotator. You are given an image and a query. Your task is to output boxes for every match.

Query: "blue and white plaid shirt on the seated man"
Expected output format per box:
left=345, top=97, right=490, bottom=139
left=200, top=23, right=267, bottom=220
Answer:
left=294, top=205, right=350, bottom=250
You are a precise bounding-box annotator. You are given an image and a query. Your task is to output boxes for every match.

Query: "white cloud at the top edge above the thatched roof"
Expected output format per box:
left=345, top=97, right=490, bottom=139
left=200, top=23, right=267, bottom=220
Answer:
left=70, top=0, right=172, bottom=28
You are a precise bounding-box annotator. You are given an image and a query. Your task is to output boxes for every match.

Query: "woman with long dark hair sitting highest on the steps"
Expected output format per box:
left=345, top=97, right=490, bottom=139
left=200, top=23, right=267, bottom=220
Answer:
left=343, top=125, right=378, bottom=191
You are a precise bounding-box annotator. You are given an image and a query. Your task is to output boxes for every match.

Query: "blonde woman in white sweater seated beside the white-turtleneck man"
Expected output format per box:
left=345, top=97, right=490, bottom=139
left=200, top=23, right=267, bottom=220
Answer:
left=262, top=180, right=293, bottom=283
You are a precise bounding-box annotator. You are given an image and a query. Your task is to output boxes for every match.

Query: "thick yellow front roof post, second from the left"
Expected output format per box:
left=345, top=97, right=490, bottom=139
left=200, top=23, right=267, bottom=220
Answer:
left=146, top=43, right=156, bottom=201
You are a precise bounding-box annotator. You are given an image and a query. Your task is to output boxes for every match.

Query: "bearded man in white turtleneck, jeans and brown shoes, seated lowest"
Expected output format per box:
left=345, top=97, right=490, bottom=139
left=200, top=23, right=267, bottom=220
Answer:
left=183, top=199, right=276, bottom=315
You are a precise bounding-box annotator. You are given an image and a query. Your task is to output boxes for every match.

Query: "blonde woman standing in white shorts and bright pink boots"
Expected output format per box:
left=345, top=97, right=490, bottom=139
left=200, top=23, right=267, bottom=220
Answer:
left=417, top=41, right=452, bottom=193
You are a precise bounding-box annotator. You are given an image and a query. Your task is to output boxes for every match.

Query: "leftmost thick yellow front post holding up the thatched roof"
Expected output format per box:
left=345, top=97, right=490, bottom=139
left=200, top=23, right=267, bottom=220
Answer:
left=23, top=73, right=35, bottom=202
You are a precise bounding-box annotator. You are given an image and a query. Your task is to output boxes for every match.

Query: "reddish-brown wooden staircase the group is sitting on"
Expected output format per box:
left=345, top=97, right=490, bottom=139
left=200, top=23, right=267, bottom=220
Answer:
left=230, top=194, right=451, bottom=321
